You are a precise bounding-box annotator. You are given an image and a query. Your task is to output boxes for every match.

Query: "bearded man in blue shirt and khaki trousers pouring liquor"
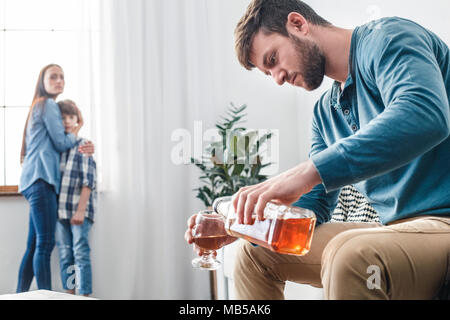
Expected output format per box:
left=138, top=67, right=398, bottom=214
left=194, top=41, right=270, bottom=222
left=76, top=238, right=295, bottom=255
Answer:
left=185, top=0, right=450, bottom=299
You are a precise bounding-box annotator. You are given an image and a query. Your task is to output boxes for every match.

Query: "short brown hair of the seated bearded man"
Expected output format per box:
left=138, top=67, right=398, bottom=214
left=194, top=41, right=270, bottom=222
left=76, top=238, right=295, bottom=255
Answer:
left=234, top=0, right=331, bottom=70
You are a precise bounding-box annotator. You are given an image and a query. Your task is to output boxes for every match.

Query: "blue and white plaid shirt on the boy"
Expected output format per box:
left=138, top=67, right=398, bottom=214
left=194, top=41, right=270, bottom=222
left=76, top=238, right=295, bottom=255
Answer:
left=58, top=138, right=97, bottom=221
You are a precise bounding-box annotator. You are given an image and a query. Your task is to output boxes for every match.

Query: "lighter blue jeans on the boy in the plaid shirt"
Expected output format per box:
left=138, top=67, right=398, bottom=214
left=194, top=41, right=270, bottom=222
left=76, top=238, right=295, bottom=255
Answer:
left=56, top=218, right=92, bottom=295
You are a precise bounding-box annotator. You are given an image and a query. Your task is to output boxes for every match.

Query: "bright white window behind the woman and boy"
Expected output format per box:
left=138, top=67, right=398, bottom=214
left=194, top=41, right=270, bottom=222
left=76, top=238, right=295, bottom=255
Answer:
left=0, top=0, right=93, bottom=191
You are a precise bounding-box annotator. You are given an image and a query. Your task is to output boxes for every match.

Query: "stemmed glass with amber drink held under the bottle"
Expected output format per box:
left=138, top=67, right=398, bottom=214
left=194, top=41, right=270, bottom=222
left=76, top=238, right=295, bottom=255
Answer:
left=192, top=210, right=228, bottom=270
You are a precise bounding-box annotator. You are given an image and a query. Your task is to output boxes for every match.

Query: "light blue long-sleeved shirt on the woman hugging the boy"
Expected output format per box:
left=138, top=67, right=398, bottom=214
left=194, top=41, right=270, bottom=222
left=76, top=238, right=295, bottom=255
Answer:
left=19, top=99, right=76, bottom=194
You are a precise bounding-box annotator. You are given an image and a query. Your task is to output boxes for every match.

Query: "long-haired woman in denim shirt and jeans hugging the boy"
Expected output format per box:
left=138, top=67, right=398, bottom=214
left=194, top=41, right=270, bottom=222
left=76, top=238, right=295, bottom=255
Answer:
left=17, top=64, right=93, bottom=292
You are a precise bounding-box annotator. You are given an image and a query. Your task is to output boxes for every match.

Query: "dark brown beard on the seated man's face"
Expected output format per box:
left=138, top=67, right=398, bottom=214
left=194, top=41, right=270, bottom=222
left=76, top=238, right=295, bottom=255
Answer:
left=289, top=34, right=326, bottom=91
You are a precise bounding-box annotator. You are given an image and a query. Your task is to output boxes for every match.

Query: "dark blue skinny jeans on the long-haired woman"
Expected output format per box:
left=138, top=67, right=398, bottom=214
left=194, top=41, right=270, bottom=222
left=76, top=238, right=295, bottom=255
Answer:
left=17, top=179, right=57, bottom=293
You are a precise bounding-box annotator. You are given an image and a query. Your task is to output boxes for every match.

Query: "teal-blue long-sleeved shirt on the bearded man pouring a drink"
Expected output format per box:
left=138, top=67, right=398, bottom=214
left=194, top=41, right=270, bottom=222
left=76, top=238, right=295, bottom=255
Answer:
left=295, top=17, right=450, bottom=224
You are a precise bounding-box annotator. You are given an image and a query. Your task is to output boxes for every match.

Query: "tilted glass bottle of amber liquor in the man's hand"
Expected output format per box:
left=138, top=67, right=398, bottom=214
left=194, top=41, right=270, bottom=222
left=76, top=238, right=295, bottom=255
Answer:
left=212, top=197, right=316, bottom=256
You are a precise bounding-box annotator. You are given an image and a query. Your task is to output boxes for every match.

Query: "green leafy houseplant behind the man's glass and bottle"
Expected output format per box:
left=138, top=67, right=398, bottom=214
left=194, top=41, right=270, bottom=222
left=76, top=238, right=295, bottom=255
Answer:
left=191, top=103, right=272, bottom=207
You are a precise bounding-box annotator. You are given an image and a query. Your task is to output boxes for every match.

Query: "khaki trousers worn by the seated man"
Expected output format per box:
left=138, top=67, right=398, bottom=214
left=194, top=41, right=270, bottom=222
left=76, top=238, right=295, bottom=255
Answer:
left=234, top=216, right=450, bottom=300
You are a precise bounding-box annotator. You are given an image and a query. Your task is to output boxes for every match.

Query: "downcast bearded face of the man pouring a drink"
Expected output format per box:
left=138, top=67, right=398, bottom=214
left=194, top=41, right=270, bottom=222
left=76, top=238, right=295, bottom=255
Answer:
left=250, top=31, right=325, bottom=91
